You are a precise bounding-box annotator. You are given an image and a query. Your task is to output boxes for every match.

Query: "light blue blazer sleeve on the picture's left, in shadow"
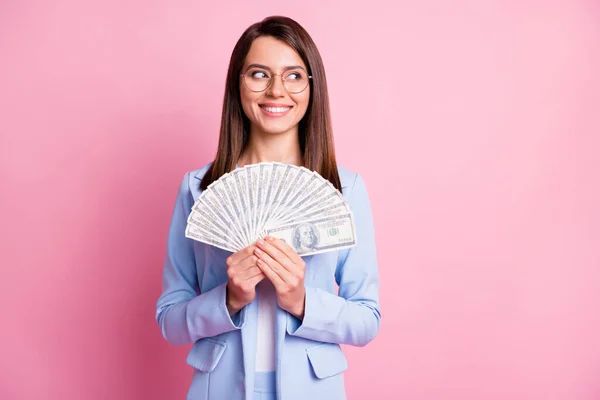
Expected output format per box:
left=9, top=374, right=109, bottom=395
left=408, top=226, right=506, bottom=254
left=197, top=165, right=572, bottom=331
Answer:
left=156, top=172, right=246, bottom=345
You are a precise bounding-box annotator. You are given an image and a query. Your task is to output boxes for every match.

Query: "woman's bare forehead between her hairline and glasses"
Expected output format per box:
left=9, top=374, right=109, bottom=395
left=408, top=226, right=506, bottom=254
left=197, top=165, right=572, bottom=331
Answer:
left=244, top=36, right=306, bottom=71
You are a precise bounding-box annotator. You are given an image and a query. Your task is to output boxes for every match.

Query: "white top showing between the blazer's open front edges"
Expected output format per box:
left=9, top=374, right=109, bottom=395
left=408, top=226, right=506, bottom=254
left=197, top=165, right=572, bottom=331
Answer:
left=255, top=278, right=277, bottom=372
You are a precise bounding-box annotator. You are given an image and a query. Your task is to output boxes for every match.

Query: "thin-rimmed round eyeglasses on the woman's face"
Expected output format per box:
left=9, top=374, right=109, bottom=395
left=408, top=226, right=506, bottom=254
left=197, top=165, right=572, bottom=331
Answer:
left=240, top=67, right=312, bottom=94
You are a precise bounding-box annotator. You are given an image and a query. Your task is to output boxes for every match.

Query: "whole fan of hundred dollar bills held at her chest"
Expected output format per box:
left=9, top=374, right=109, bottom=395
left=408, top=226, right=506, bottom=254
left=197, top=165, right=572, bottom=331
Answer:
left=185, top=162, right=356, bottom=256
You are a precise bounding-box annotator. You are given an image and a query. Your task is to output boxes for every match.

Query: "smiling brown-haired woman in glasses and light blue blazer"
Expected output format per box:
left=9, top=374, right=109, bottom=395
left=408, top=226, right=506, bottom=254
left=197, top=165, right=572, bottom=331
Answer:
left=156, top=17, right=380, bottom=400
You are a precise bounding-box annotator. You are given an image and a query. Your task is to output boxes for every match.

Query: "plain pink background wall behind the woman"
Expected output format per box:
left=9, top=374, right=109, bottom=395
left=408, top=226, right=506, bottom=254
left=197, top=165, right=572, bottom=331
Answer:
left=0, top=0, right=600, bottom=400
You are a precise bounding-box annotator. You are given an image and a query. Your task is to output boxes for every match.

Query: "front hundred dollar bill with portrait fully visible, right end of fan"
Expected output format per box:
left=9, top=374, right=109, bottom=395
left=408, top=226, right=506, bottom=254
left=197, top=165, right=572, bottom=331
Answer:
left=263, top=212, right=357, bottom=256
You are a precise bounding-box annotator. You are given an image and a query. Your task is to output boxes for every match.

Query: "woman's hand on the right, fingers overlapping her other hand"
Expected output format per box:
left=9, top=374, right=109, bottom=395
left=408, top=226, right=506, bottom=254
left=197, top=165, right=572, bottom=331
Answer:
left=254, top=236, right=306, bottom=319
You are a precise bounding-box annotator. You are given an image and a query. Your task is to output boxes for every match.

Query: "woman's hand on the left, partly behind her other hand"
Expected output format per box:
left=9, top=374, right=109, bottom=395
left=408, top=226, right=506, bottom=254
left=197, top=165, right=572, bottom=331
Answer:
left=226, top=245, right=265, bottom=315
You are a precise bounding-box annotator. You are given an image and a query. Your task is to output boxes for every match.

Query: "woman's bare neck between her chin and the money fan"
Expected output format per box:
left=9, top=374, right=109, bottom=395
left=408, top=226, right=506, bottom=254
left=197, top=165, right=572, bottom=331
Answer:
left=238, top=127, right=304, bottom=167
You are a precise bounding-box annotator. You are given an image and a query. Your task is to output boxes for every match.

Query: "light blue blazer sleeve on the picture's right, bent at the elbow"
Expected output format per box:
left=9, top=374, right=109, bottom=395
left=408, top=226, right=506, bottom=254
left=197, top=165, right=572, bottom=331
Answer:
left=287, top=174, right=381, bottom=346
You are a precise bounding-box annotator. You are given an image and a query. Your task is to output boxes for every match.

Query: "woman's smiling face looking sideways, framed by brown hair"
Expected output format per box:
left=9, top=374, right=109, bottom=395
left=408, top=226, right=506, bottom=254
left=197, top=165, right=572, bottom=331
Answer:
left=240, top=36, right=310, bottom=135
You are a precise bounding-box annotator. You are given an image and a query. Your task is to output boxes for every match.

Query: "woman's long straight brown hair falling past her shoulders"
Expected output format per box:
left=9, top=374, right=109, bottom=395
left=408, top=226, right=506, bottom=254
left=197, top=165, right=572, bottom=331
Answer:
left=200, top=16, right=342, bottom=191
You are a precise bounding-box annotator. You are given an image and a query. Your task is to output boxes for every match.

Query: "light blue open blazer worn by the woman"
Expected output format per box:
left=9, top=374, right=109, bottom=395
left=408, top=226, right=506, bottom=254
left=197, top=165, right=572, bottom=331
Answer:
left=156, top=164, right=381, bottom=400
